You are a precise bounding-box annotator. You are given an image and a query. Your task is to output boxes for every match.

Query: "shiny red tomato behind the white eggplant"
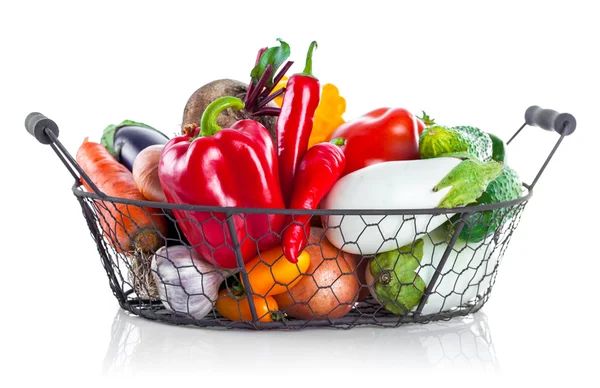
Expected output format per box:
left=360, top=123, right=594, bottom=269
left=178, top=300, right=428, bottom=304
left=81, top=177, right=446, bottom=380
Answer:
left=329, top=108, right=419, bottom=176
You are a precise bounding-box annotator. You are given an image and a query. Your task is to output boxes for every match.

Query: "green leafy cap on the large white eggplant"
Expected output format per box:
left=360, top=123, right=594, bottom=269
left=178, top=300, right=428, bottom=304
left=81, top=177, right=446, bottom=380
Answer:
left=433, top=155, right=504, bottom=208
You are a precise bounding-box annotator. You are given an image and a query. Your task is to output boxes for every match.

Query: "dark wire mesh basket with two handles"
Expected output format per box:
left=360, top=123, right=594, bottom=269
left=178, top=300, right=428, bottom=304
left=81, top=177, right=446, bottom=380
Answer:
left=25, top=106, right=576, bottom=329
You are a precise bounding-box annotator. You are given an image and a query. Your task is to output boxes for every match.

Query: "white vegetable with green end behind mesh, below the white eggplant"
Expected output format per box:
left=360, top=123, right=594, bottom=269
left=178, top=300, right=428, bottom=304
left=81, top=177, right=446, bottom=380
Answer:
left=365, top=226, right=507, bottom=315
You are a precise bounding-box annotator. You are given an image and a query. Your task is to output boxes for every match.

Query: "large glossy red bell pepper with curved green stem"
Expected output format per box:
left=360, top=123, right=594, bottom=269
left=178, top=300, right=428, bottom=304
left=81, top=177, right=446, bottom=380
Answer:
left=158, top=97, right=285, bottom=268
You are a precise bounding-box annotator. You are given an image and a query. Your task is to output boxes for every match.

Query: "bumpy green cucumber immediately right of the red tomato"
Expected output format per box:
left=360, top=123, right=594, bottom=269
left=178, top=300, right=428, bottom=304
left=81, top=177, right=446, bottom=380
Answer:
left=419, top=125, right=492, bottom=162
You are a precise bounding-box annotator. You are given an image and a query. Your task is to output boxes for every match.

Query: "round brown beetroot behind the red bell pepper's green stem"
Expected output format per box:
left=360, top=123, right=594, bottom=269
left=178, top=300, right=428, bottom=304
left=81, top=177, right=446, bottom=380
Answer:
left=181, top=79, right=277, bottom=144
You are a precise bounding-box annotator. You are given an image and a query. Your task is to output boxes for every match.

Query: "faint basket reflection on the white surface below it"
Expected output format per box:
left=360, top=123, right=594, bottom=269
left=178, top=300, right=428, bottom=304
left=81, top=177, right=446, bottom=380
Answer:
left=104, top=309, right=500, bottom=374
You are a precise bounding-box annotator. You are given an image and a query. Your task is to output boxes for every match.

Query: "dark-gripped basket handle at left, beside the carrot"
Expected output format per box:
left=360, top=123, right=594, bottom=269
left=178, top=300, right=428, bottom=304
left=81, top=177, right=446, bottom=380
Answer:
left=25, top=112, right=106, bottom=198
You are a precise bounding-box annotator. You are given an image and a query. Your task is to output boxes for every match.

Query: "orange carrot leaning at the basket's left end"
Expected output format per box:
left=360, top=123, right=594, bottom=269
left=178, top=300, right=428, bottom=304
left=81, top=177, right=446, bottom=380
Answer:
left=76, top=138, right=167, bottom=252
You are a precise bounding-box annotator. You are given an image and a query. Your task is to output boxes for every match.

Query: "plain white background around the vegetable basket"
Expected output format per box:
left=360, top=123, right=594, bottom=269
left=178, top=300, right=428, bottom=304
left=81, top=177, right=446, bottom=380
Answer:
left=0, top=0, right=600, bottom=387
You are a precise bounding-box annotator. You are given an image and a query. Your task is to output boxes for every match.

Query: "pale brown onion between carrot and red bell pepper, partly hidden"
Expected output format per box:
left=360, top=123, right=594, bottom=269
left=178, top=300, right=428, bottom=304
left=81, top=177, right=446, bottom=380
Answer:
left=131, top=144, right=167, bottom=202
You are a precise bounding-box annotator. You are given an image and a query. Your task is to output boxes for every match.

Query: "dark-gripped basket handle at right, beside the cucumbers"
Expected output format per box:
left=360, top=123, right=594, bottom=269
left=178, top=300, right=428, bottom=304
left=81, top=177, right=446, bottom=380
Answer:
left=506, top=105, right=577, bottom=190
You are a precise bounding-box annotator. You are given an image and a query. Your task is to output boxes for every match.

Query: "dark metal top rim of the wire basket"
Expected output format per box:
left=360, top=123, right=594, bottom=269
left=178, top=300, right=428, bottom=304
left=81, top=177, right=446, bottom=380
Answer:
left=72, top=181, right=533, bottom=216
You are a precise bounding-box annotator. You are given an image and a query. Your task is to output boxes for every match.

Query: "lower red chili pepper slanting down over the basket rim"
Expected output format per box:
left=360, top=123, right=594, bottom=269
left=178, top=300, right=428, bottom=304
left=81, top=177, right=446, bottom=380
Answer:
left=282, top=139, right=346, bottom=263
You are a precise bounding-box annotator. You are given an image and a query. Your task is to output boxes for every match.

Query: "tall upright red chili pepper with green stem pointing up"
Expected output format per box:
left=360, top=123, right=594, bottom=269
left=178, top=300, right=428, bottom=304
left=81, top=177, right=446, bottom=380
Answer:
left=277, top=42, right=321, bottom=205
